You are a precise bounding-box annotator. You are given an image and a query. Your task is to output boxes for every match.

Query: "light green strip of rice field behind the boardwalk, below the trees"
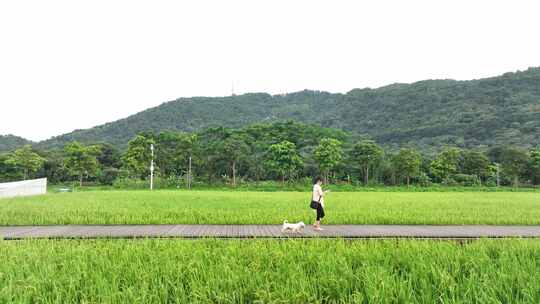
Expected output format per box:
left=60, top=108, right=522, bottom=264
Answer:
left=0, top=190, right=540, bottom=225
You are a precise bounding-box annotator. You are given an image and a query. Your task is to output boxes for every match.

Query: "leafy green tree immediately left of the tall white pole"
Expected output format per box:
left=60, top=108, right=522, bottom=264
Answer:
left=122, top=134, right=155, bottom=179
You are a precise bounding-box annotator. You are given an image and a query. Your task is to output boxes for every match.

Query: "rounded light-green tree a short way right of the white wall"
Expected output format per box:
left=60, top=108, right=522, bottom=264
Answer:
left=64, top=141, right=99, bottom=187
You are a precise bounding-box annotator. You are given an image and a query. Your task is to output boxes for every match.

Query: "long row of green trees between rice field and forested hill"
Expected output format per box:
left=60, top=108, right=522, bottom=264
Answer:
left=0, top=121, right=540, bottom=186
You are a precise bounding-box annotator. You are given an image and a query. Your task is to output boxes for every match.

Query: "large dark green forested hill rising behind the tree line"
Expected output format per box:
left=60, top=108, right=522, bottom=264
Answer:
left=25, top=68, right=540, bottom=150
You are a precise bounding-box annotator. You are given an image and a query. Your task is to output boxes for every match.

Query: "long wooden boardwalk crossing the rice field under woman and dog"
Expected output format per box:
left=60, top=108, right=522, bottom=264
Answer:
left=0, top=225, right=540, bottom=240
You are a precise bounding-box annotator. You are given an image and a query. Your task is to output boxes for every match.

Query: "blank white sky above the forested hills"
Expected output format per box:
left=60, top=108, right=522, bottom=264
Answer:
left=0, top=0, right=540, bottom=140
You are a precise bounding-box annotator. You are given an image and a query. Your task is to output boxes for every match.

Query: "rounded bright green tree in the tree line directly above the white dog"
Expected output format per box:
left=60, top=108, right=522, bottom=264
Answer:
left=266, top=141, right=303, bottom=183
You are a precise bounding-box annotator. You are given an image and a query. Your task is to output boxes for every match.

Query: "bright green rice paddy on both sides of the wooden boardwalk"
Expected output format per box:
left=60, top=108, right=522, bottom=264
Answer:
left=0, top=191, right=540, bottom=303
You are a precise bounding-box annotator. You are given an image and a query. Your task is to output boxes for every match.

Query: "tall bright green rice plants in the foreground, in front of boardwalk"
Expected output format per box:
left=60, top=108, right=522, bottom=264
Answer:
left=0, top=239, right=540, bottom=303
